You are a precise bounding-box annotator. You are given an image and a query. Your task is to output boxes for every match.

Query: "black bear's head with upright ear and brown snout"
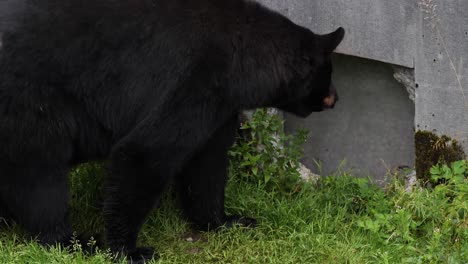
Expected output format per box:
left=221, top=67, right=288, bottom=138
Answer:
left=278, top=27, right=345, bottom=117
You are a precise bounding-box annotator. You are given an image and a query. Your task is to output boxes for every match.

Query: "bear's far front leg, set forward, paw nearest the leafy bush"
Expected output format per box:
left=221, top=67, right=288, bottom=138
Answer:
left=177, top=114, right=256, bottom=230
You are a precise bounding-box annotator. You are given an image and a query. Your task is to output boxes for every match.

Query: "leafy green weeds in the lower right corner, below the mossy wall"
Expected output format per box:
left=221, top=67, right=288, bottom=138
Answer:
left=357, top=160, right=468, bottom=263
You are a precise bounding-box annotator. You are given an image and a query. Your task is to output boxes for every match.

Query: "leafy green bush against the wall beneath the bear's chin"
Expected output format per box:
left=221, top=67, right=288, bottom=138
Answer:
left=229, top=109, right=307, bottom=193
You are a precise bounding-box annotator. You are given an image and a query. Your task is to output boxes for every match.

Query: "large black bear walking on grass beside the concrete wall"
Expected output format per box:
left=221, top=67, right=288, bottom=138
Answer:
left=0, top=0, right=344, bottom=260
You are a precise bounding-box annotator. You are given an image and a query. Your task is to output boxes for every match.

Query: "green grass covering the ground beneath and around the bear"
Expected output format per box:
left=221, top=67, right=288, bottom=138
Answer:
left=0, top=165, right=468, bottom=264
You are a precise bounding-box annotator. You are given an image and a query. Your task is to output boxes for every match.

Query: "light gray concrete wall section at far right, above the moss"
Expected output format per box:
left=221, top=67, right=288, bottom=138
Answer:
left=415, top=0, right=468, bottom=148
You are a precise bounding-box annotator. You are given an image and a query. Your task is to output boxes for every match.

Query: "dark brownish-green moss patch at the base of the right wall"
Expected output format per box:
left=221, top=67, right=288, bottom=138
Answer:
left=415, top=131, right=466, bottom=183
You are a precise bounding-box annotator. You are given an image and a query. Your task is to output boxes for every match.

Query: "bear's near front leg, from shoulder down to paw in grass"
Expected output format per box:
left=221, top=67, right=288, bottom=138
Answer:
left=104, top=102, right=231, bottom=263
